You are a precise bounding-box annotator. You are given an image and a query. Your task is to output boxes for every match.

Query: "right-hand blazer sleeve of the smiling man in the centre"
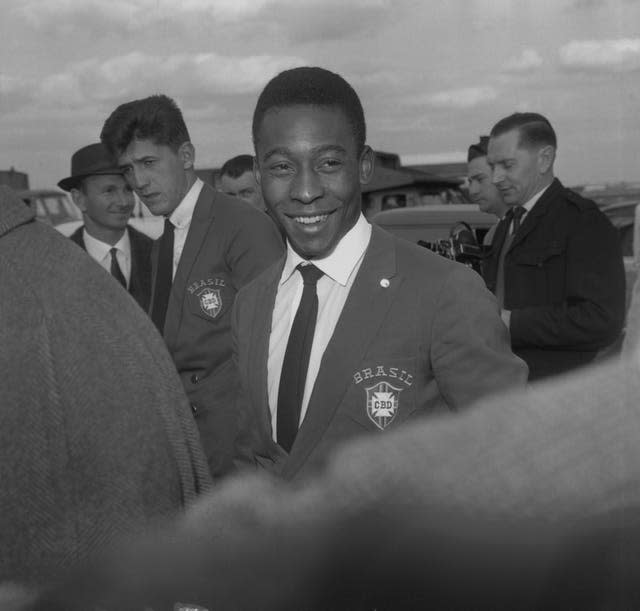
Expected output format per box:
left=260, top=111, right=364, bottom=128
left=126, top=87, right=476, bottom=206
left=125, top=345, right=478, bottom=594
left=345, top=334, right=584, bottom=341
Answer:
left=431, top=264, right=528, bottom=409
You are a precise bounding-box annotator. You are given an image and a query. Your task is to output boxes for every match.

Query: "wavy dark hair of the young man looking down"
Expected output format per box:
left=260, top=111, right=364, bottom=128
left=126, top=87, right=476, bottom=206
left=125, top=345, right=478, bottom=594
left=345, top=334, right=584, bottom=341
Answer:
left=100, top=95, right=191, bottom=157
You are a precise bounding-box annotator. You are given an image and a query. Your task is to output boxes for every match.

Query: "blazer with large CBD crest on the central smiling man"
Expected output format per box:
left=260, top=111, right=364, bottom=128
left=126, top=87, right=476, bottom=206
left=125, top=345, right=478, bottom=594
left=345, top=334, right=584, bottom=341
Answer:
left=233, top=226, right=527, bottom=479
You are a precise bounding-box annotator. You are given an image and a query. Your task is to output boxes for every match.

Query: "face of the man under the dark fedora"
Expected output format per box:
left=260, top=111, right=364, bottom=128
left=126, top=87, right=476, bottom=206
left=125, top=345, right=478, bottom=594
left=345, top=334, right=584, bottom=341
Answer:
left=72, top=174, right=135, bottom=230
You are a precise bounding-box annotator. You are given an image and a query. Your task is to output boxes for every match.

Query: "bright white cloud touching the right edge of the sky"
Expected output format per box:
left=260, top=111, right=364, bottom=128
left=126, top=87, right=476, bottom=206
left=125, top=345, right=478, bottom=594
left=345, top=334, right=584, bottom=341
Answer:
left=559, top=38, right=640, bottom=72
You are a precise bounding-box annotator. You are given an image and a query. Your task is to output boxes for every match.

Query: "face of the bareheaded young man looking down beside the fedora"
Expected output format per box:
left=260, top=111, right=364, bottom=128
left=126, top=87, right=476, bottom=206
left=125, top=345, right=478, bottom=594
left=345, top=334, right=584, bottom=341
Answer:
left=118, top=140, right=193, bottom=216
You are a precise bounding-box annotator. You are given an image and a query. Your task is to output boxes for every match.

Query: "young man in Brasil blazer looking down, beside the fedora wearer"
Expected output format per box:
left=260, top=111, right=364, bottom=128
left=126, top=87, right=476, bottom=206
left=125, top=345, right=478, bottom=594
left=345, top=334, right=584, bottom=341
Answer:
left=101, top=95, right=283, bottom=476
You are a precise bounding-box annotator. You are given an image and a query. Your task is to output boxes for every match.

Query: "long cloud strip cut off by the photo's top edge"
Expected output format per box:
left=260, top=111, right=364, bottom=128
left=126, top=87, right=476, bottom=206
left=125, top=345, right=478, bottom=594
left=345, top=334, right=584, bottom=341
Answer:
left=18, top=0, right=406, bottom=43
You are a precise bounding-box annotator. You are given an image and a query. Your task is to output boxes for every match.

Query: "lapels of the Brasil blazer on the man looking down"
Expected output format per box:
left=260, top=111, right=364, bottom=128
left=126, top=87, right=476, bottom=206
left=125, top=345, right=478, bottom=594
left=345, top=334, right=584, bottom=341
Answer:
left=162, top=183, right=215, bottom=347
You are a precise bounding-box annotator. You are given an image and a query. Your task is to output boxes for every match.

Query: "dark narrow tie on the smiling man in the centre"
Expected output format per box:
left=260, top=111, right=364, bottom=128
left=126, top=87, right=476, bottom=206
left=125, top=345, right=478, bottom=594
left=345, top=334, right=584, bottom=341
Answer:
left=277, top=265, right=323, bottom=452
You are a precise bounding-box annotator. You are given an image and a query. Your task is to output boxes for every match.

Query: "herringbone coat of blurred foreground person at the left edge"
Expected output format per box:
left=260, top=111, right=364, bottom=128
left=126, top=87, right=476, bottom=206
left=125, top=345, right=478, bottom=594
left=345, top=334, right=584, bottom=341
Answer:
left=0, top=187, right=209, bottom=592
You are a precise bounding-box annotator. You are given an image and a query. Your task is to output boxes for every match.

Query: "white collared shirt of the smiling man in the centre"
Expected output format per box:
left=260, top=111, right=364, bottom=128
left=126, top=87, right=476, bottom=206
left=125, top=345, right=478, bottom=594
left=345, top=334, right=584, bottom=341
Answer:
left=267, top=214, right=371, bottom=441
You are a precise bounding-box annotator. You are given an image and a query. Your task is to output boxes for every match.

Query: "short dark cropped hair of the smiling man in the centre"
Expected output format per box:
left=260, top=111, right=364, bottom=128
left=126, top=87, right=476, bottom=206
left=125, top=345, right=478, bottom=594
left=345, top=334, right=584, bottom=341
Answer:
left=252, top=66, right=367, bottom=152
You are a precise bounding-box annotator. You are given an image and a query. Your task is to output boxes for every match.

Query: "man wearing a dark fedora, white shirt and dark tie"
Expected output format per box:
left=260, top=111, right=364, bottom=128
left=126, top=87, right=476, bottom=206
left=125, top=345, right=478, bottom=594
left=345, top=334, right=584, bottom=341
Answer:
left=58, top=142, right=152, bottom=311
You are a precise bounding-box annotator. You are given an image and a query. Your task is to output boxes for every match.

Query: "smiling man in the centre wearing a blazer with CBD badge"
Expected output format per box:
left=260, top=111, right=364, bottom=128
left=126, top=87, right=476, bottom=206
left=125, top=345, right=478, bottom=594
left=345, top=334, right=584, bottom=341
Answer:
left=234, top=68, right=527, bottom=478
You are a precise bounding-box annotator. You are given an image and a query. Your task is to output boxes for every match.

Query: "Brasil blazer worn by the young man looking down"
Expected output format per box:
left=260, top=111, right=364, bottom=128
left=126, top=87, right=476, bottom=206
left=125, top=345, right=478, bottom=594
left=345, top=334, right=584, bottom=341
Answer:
left=149, top=183, right=284, bottom=476
